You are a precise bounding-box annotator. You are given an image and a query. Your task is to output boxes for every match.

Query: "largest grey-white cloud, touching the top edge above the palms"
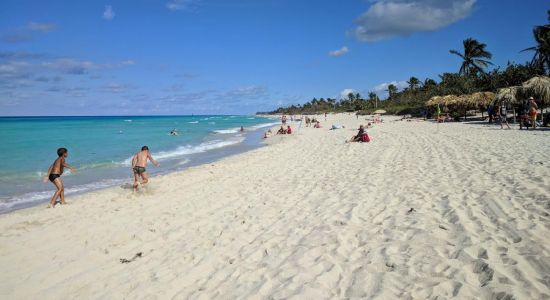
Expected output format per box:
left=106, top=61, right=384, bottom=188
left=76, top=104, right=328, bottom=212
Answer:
left=349, top=0, right=477, bottom=42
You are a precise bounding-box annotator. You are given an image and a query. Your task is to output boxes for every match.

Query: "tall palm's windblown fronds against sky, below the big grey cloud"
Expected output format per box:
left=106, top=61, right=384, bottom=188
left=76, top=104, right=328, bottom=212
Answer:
left=450, top=38, right=493, bottom=75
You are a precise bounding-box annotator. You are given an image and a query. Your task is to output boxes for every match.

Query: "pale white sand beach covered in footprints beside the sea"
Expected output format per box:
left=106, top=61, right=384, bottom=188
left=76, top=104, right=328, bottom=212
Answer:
left=0, top=114, right=550, bottom=299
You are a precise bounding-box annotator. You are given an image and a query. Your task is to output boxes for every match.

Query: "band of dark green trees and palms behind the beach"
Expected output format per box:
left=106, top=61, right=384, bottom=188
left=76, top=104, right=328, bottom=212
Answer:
left=264, top=10, right=550, bottom=115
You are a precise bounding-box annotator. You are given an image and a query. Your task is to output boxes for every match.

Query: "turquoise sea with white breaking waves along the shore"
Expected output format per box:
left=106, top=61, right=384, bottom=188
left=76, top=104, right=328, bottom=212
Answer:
left=0, top=116, right=276, bottom=212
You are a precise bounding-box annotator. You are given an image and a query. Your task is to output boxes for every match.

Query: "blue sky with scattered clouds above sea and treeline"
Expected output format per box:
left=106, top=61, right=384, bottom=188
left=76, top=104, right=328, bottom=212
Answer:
left=0, top=0, right=550, bottom=116
